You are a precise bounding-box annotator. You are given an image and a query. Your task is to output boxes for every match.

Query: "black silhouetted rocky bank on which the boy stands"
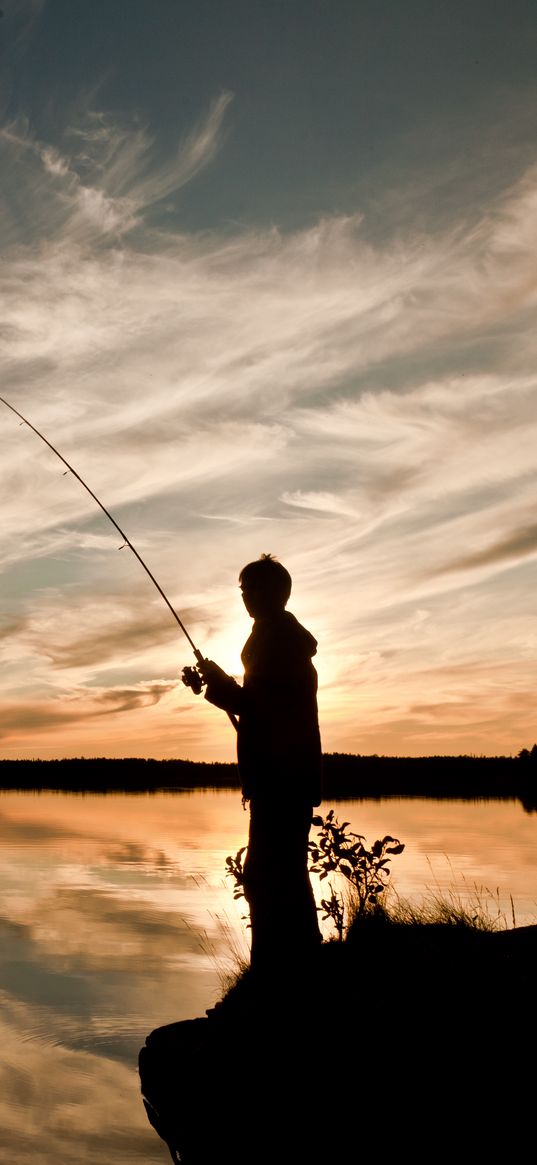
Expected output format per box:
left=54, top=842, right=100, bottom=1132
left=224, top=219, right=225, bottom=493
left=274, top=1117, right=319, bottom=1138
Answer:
left=140, top=915, right=537, bottom=1165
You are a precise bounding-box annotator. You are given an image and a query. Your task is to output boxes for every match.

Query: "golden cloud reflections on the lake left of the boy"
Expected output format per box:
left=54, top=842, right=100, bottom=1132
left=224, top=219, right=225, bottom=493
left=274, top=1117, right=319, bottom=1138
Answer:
left=0, top=793, right=243, bottom=1165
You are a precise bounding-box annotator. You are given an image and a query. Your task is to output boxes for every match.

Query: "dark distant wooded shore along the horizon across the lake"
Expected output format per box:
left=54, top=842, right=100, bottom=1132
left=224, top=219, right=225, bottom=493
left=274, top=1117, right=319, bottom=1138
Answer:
left=0, top=753, right=537, bottom=812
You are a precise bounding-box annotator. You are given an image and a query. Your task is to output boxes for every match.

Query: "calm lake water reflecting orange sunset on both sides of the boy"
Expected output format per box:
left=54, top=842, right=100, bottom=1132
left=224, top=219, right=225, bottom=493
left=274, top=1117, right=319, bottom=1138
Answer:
left=0, top=791, right=537, bottom=1165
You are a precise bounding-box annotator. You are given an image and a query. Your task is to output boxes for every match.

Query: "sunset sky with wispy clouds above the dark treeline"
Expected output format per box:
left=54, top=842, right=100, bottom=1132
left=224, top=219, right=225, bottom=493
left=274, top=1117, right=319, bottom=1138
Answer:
left=0, top=0, right=537, bottom=761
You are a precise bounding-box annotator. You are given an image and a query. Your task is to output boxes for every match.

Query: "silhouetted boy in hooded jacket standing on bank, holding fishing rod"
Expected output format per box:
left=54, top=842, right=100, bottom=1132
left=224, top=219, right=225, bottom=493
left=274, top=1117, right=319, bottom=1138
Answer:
left=200, top=555, right=322, bottom=967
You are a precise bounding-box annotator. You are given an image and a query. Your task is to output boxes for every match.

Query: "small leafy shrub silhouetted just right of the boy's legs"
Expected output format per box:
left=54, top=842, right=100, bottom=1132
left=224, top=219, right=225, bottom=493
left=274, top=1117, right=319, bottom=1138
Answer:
left=309, top=809, right=404, bottom=939
